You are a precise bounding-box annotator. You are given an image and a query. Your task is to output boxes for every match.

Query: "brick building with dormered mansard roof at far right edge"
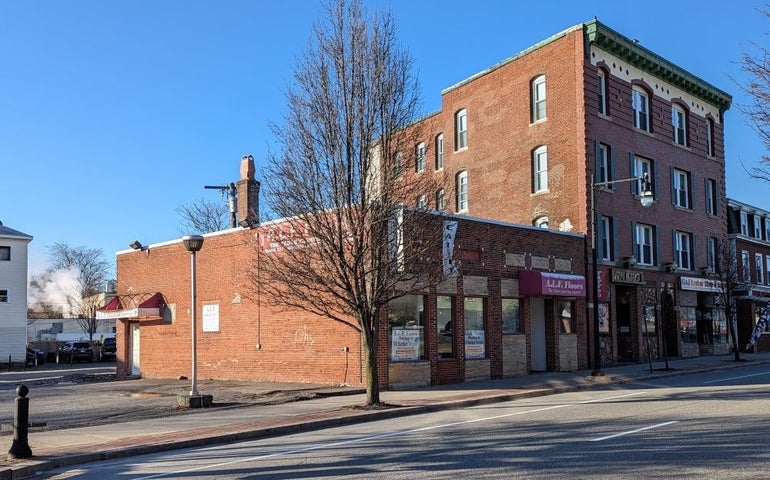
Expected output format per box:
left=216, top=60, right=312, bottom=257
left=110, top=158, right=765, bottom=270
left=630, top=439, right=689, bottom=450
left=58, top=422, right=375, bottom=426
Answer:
left=727, top=199, right=770, bottom=352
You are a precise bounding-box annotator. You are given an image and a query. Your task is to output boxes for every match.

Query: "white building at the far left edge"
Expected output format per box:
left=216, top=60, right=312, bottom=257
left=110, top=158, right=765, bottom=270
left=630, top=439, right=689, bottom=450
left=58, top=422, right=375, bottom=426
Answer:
left=0, top=222, right=32, bottom=364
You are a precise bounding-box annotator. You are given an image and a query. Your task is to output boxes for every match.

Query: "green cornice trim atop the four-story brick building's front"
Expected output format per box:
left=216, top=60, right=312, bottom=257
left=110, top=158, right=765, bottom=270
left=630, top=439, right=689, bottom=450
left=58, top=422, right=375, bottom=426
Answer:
left=583, top=20, right=733, bottom=113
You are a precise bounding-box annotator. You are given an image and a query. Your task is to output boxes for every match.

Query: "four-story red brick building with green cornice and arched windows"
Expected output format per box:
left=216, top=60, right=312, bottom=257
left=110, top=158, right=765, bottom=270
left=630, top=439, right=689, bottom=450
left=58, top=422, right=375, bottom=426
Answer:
left=400, top=20, right=732, bottom=363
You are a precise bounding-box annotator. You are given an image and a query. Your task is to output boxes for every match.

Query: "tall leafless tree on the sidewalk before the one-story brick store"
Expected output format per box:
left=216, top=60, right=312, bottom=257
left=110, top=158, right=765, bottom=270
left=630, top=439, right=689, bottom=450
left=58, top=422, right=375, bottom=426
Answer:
left=251, top=0, right=442, bottom=405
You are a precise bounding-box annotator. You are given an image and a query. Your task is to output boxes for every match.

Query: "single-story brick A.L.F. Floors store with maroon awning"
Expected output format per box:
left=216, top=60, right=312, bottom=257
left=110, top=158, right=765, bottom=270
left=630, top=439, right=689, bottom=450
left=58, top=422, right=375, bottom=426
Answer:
left=97, top=158, right=588, bottom=387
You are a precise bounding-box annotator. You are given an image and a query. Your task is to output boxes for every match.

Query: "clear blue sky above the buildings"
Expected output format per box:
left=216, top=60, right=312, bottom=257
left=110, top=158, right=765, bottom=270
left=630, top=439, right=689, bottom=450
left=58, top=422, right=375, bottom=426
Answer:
left=0, top=0, right=770, bottom=278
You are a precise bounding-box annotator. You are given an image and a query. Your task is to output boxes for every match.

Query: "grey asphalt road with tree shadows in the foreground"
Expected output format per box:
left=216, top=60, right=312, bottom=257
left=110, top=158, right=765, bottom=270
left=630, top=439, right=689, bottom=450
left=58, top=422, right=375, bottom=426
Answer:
left=37, top=365, right=770, bottom=480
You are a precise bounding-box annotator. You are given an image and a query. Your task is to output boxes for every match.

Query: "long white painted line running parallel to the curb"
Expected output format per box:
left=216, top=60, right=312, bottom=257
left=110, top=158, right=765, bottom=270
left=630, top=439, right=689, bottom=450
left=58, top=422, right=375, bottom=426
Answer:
left=130, top=392, right=646, bottom=480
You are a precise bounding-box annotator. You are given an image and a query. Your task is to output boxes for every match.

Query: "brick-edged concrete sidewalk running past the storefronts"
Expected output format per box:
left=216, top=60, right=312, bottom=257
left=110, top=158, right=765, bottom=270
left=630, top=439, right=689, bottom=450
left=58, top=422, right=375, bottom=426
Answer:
left=6, top=353, right=770, bottom=480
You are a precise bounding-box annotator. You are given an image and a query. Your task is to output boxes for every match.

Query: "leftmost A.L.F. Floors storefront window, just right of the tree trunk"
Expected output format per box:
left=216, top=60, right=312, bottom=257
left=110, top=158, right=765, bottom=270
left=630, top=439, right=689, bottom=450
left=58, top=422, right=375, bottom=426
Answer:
left=388, top=295, right=425, bottom=362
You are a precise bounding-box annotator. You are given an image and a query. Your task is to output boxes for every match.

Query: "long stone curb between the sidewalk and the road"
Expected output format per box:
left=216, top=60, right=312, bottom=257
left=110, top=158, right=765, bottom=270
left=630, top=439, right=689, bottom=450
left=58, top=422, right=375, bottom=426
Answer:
left=7, top=360, right=770, bottom=480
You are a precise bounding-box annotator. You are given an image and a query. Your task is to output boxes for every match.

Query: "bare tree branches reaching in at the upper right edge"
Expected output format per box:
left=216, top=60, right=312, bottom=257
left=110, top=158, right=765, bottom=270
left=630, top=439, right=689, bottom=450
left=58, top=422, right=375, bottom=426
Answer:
left=738, top=9, right=770, bottom=182
